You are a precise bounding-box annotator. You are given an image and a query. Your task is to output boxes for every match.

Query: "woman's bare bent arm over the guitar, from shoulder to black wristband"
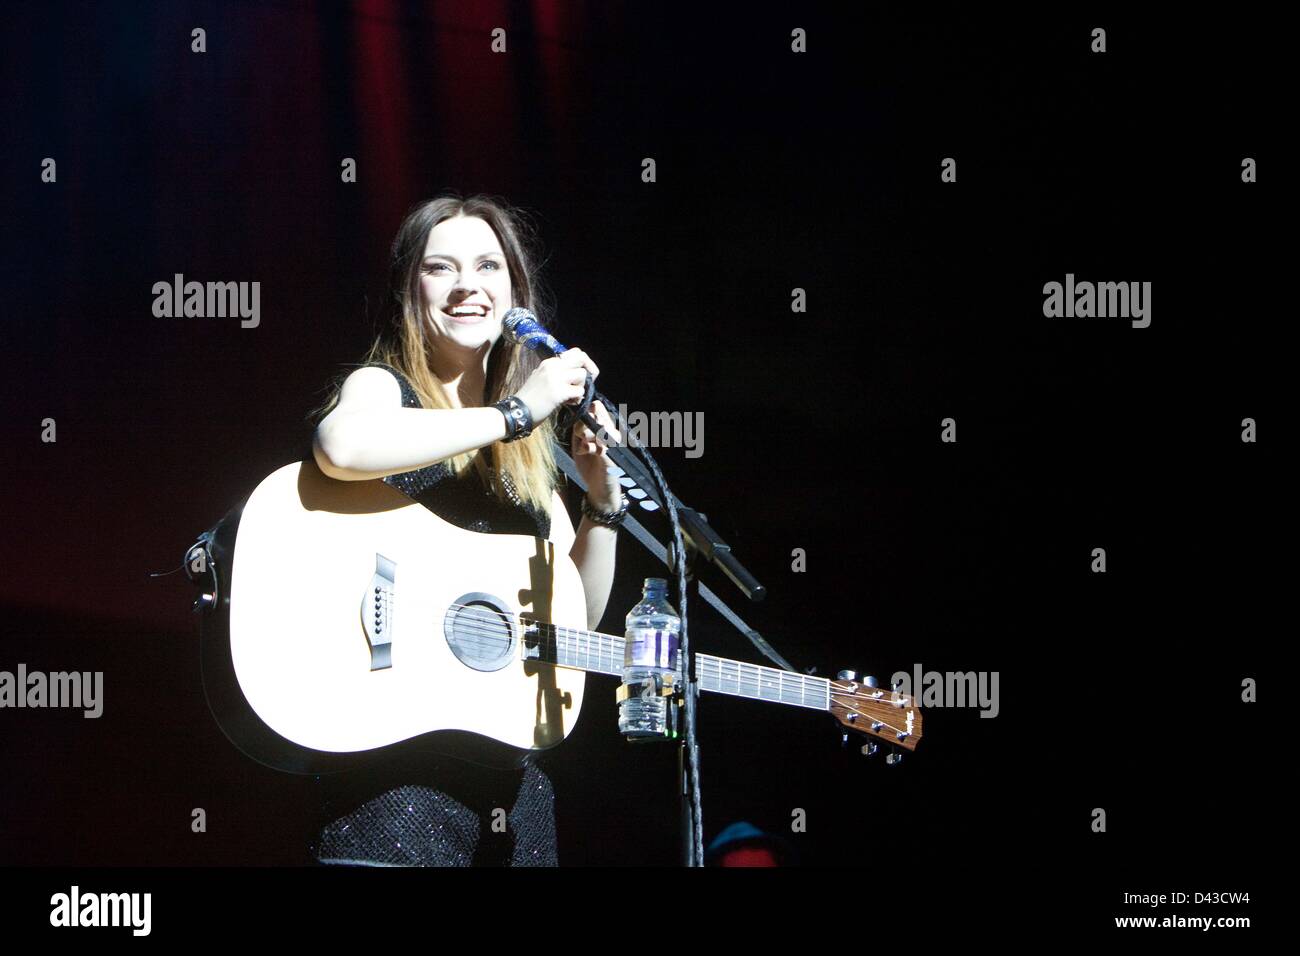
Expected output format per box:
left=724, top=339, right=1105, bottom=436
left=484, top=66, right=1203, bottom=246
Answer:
left=312, top=367, right=506, bottom=481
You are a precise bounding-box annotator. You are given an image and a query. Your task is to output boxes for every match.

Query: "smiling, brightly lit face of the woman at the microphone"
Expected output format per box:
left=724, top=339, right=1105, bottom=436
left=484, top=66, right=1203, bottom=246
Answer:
left=420, top=216, right=512, bottom=350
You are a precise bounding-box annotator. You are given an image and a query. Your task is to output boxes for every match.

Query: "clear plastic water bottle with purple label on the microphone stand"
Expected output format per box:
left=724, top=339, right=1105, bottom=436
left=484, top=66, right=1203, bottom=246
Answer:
left=619, top=578, right=681, bottom=740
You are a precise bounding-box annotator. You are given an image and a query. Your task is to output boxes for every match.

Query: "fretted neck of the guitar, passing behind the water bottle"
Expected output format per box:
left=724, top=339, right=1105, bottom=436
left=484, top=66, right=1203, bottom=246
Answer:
left=524, top=622, right=831, bottom=710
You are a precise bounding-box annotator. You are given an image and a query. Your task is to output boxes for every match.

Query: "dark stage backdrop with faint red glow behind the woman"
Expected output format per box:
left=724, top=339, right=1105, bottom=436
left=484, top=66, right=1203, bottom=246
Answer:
left=0, top=3, right=1291, bottom=920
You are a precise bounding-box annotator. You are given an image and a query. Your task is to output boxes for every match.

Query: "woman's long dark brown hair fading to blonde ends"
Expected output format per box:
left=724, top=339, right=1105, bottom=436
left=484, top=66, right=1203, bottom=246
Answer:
left=315, top=194, right=555, bottom=511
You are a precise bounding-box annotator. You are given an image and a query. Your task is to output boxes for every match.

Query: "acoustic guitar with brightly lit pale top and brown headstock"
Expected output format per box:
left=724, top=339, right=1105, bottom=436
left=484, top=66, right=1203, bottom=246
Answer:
left=187, top=459, right=922, bottom=773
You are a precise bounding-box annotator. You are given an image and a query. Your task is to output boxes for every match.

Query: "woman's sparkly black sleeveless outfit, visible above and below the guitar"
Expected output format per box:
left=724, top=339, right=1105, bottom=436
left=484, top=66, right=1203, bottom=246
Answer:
left=311, top=363, right=558, bottom=866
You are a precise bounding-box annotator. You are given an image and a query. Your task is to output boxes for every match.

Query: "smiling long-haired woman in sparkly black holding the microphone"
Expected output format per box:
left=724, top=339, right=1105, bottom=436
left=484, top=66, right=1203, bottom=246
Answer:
left=312, top=196, right=628, bottom=866
